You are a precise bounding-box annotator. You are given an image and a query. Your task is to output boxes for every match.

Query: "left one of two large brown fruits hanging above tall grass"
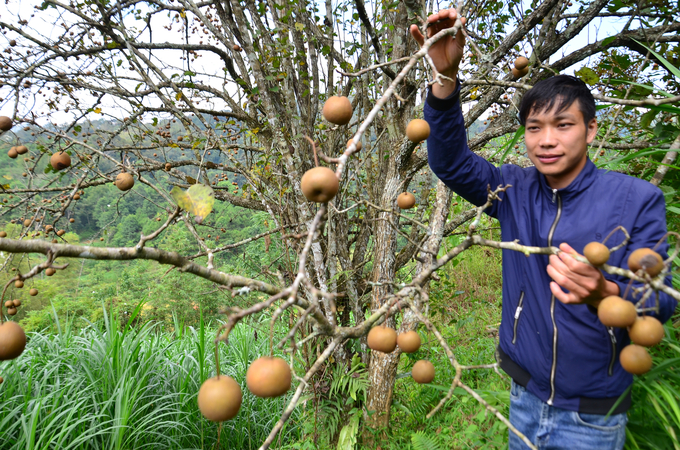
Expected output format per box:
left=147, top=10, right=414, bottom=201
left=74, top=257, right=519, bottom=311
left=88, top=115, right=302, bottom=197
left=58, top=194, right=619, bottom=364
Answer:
left=198, top=375, right=243, bottom=422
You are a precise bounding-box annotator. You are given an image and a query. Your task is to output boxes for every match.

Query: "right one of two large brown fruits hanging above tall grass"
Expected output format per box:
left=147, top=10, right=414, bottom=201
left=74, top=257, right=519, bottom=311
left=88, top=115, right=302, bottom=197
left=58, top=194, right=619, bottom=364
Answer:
left=246, top=356, right=291, bottom=398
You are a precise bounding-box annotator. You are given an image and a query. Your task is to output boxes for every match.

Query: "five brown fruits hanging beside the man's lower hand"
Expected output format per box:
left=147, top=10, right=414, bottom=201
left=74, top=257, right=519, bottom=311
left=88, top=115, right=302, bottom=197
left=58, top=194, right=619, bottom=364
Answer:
left=583, top=242, right=665, bottom=375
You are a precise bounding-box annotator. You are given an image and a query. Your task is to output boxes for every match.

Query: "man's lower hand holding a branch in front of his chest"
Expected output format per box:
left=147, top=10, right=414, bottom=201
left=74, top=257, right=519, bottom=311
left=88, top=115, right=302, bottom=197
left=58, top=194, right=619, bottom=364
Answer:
left=547, top=243, right=619, bottom=308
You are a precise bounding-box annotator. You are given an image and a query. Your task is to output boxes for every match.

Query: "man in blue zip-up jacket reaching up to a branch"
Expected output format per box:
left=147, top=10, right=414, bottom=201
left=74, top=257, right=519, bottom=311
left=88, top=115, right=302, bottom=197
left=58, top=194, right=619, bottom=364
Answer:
left=410, top=9, right=676, bottom=450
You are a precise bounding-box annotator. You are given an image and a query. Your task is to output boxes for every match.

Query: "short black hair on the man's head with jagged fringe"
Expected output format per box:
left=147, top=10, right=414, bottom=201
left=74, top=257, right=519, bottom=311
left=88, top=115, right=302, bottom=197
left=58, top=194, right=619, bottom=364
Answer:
left=519, top=75, right=595, bottom=126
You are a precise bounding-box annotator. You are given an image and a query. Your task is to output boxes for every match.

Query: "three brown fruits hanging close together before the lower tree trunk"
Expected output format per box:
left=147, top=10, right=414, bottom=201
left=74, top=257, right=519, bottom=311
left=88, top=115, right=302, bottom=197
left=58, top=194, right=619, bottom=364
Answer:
left=366, top=325, right=434, bottom=384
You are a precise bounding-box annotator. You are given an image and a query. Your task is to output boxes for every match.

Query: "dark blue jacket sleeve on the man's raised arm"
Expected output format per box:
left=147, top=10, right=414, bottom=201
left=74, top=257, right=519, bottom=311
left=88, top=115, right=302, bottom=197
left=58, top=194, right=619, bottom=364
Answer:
left=424, top=82, right=503, bottom=217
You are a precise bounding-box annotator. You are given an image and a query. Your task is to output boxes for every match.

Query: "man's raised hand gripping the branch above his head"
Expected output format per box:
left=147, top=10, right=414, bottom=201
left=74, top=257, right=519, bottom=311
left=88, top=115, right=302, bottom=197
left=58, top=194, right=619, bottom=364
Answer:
left=409, top=9, right=465, bottom=98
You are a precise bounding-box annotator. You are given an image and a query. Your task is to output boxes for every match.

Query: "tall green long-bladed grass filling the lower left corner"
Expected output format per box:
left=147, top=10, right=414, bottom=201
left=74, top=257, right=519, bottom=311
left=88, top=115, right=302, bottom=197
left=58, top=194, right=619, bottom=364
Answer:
left=0, top=304, right=299, bottom=450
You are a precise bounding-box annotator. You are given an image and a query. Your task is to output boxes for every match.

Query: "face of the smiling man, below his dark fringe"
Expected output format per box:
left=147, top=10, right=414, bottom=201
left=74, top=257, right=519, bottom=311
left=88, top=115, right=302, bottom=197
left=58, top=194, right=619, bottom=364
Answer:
left=524, top=101, right=597, bottom=189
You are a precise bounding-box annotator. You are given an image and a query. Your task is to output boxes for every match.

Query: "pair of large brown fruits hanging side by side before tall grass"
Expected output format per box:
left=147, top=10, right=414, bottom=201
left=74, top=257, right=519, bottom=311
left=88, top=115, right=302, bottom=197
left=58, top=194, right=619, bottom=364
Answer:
left=198, top=356, right=292, bottom=422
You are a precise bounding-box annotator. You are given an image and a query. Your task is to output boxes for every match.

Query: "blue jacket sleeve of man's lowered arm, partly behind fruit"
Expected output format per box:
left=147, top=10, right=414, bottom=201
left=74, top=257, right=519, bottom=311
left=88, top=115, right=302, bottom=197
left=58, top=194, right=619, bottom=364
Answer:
left=605, top=185, right=678, bottom=323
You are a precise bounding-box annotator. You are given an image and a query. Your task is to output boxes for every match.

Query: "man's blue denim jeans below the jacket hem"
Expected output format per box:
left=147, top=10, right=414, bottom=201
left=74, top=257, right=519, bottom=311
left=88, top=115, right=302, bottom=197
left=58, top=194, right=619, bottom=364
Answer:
left=508, top=381, right=628, bottom=450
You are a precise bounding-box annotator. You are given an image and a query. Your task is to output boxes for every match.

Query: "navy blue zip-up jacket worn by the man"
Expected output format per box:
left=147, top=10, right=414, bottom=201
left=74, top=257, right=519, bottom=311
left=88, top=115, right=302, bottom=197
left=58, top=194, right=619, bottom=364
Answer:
left=424, top=83, right=676, bottom=414
